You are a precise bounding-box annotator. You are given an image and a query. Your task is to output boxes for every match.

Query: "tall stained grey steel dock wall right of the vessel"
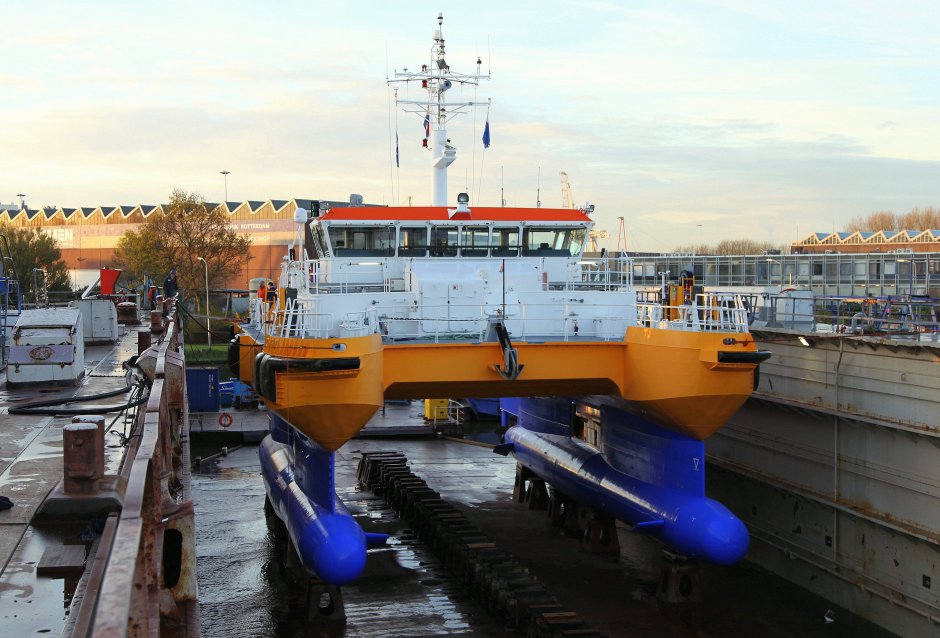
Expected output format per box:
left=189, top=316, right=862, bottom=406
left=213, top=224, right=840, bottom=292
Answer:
left=706, top=333, right=940, bottom=635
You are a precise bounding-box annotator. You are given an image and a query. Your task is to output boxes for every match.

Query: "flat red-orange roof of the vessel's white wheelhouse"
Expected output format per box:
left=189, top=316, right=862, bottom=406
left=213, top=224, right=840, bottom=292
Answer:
left=320, top=206, right=590, bottom=222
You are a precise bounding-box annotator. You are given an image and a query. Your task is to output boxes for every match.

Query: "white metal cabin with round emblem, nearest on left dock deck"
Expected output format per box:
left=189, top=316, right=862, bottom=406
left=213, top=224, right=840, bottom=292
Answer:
left=7, top=308, right=85, bottom=388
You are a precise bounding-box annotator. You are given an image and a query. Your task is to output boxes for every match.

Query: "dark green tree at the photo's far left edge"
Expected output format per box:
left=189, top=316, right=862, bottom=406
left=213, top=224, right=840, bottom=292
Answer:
left=0, top=224, right=72, bottom=301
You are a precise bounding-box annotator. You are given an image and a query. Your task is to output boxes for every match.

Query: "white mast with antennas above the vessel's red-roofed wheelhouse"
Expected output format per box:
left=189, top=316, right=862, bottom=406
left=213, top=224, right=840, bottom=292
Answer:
left=388, top=13, right=490, bottom=206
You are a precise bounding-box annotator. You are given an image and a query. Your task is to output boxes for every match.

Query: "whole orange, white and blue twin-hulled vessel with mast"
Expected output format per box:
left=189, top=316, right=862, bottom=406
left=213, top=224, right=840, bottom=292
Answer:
left=230, top=17, right=769, bottom=585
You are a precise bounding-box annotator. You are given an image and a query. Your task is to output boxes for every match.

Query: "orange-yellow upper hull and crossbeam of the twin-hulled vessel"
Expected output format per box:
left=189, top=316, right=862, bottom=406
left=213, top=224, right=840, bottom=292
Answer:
left=241, top=328, right=757, bottom=450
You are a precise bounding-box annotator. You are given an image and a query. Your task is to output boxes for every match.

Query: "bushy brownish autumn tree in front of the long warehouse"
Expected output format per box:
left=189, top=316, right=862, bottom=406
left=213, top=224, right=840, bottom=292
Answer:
left=114, top=189, right=251, bottom=303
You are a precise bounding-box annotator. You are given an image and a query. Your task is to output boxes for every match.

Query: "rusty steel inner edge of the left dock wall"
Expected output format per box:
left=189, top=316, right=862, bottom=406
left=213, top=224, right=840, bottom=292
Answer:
left=70, top=308, right=200, bottom=638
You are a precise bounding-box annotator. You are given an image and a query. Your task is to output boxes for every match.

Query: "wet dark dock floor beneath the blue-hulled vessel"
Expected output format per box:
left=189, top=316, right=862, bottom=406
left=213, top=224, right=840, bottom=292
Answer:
left=193, top=424, right=891, bottom=638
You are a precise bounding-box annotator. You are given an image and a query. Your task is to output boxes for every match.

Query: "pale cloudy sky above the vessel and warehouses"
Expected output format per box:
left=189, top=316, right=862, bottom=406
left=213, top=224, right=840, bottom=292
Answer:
left=0, top=0, right=940, bottom=252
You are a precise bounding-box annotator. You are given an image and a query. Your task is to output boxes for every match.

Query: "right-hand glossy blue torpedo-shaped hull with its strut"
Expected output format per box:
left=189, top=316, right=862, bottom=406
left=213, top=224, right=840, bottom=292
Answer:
left=504, top=399, right=749, bottom=565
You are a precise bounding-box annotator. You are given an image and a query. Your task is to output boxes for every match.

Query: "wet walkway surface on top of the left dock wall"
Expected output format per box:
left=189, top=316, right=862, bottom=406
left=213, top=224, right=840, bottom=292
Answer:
left=0, top=331, right=145, bottom=637
